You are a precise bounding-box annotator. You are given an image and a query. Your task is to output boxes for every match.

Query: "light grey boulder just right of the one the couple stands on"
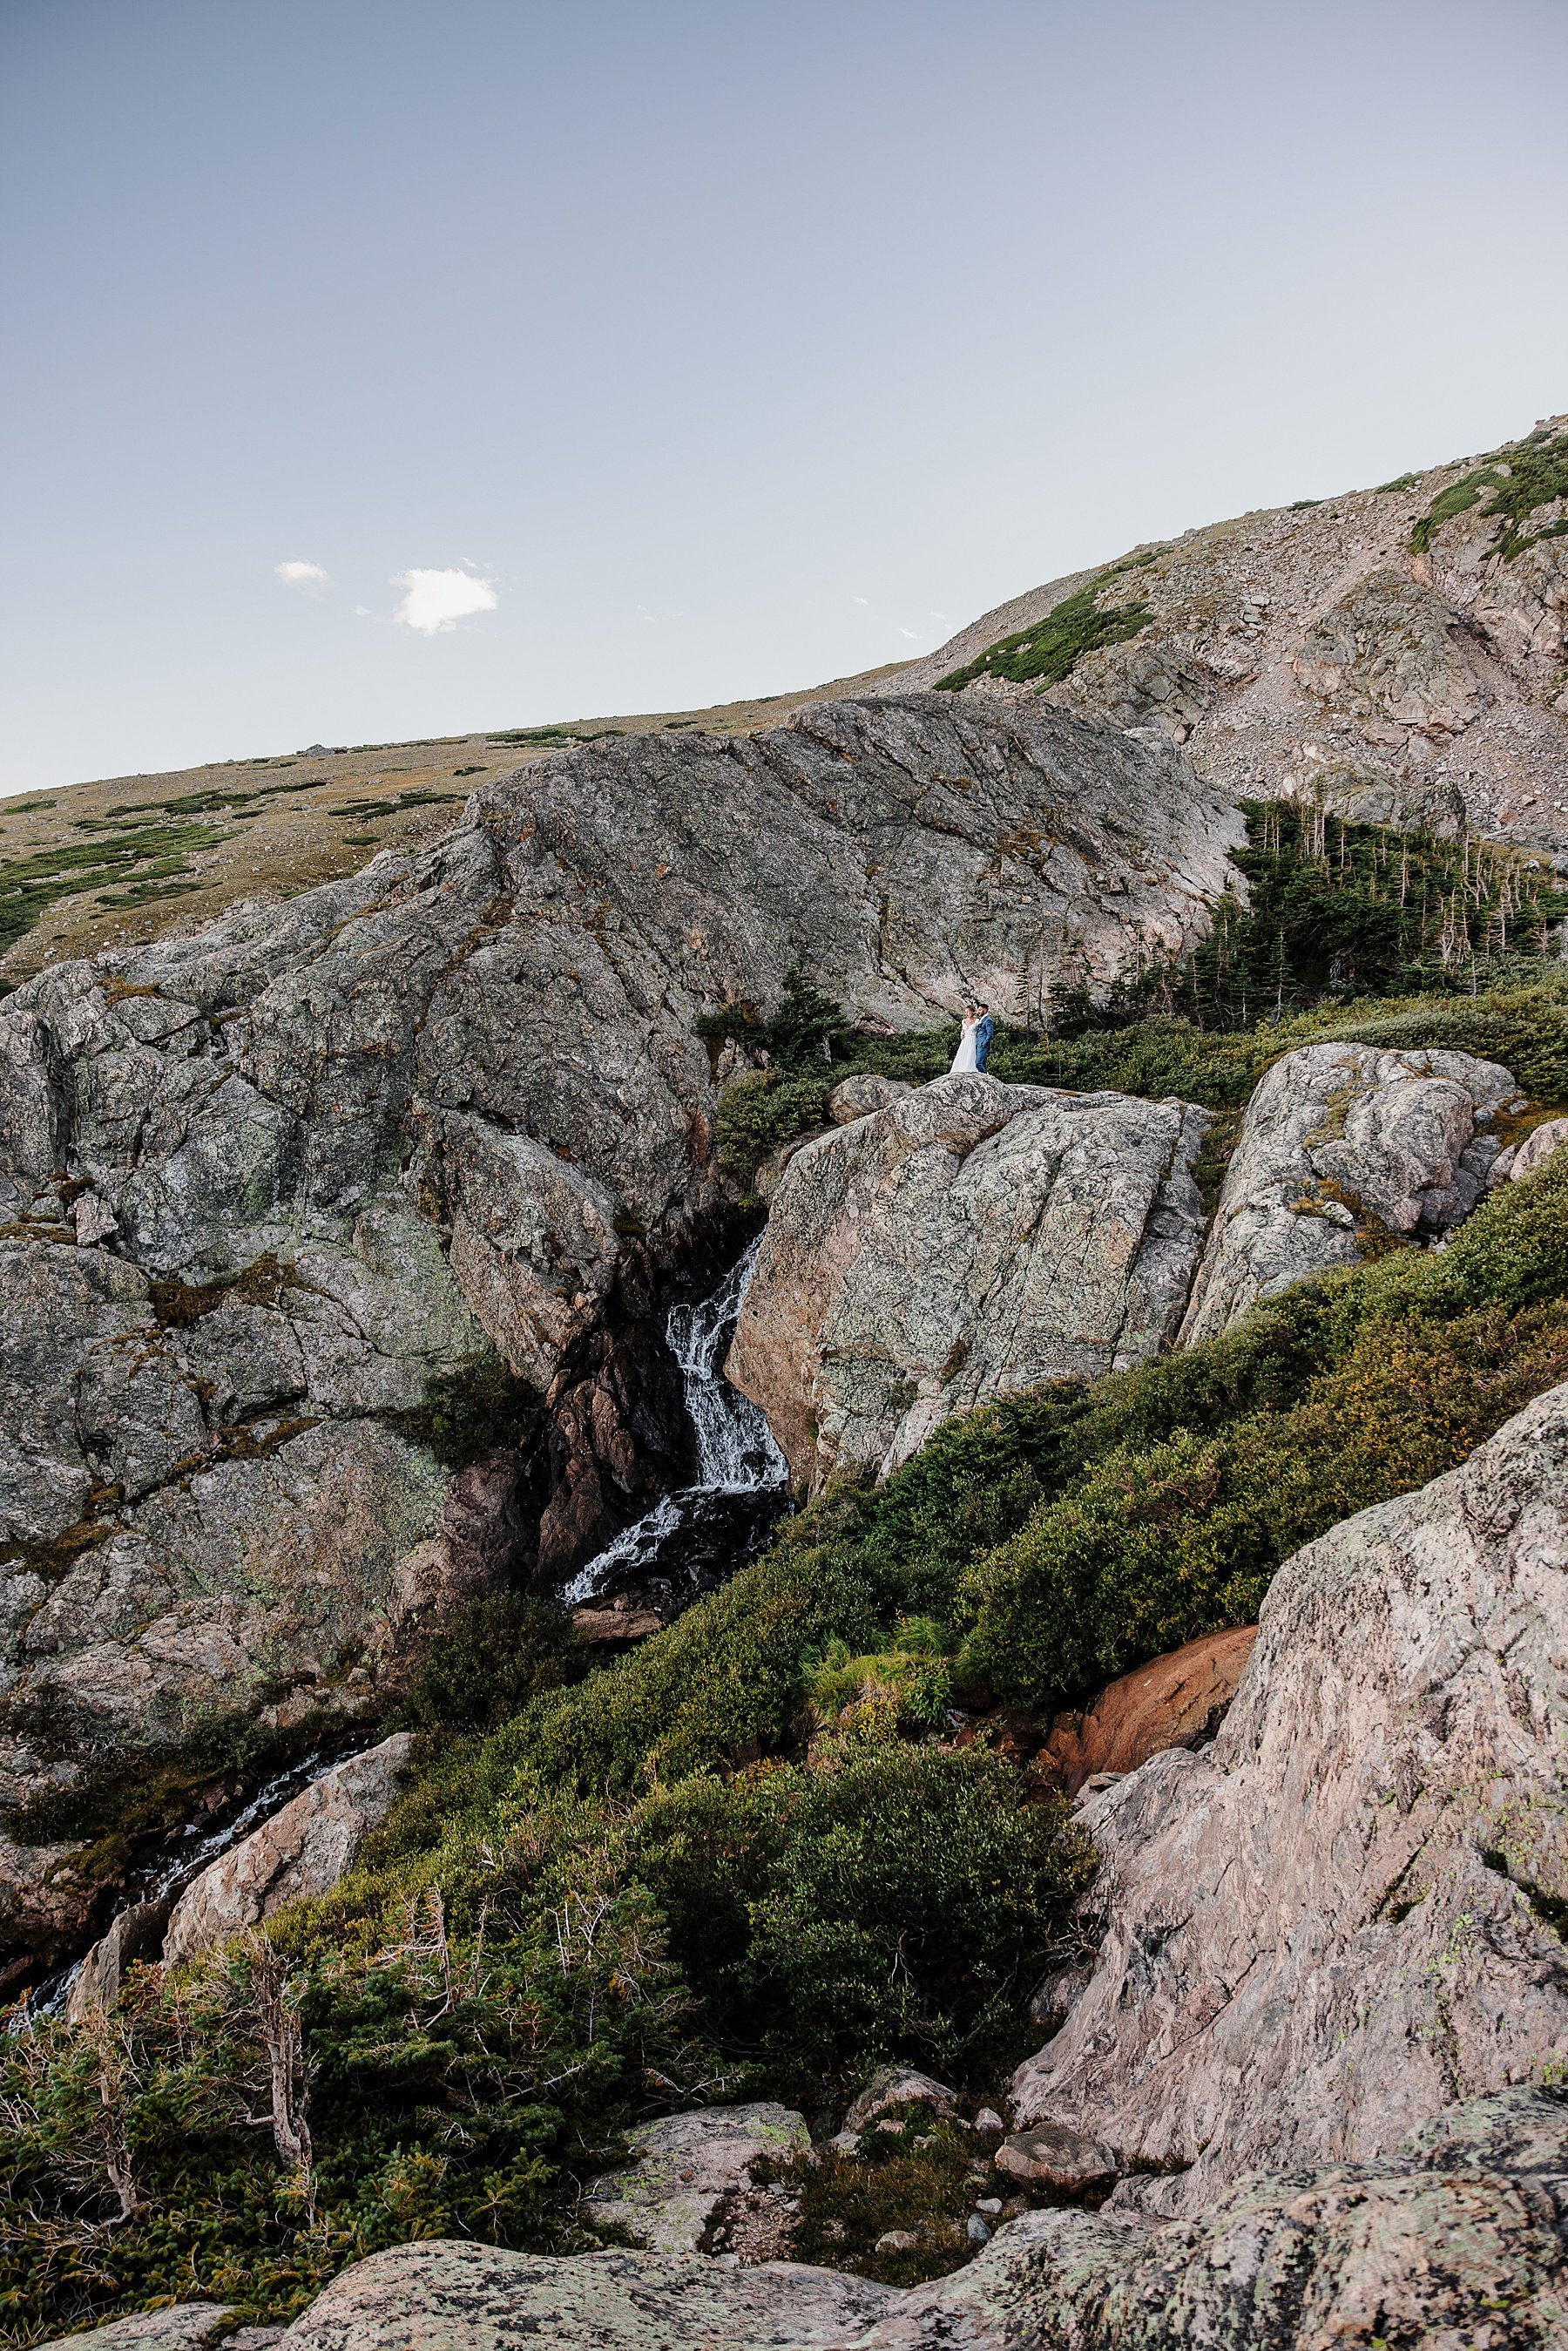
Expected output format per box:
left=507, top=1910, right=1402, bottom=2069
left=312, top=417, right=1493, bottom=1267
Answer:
left=1180, top=1044, right=1521, bottom=1347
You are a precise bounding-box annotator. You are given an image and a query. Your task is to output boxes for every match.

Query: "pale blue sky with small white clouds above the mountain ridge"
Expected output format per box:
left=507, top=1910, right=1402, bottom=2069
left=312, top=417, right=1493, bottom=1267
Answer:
left=0, top=0, right=1568, bottom=795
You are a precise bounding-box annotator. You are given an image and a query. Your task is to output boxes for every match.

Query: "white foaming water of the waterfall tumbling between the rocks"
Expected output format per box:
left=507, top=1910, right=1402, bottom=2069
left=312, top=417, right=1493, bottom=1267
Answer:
left=562, top=1239, right=790, bottom=1608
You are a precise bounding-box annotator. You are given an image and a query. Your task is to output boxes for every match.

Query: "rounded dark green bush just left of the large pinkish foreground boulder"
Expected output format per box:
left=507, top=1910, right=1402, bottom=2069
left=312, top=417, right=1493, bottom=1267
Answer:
left=632, top=1735, right=1091, bottom=2106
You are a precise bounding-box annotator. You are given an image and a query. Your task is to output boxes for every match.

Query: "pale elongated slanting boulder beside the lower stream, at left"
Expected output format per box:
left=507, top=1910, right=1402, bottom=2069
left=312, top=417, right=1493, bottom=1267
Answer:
left=162, top=1731, right=414, bottom=1966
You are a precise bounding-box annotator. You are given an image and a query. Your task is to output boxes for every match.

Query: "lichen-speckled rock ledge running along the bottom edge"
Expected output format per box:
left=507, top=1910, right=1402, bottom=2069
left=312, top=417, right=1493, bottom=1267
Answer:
left=44, top=2090, right=1568, bottom=2351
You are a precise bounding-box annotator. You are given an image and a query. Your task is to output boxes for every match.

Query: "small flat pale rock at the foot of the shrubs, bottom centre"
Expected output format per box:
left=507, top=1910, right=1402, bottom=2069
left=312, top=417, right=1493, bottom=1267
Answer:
left=583, top=2099, right=811, bottom=2253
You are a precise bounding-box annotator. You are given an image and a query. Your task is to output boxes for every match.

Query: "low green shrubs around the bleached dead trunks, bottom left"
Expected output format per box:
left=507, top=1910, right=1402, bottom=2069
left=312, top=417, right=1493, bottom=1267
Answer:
left=0, top=1803, right=709, bottom=2341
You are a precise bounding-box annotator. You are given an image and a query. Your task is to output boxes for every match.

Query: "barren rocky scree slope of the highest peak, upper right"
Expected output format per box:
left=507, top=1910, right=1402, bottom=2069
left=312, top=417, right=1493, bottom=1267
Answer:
left=896, top=417, right=1568, bottom=849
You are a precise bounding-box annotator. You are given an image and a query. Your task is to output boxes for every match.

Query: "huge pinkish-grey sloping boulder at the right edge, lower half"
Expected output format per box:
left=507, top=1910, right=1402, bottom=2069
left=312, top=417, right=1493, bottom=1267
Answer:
left=1013, top=1387, right=1568, bottom=2215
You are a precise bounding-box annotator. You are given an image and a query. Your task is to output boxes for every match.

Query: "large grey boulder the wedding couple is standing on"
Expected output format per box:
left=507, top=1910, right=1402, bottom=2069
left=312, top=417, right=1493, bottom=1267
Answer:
left=727, top=1074, right=1206, bottom=1486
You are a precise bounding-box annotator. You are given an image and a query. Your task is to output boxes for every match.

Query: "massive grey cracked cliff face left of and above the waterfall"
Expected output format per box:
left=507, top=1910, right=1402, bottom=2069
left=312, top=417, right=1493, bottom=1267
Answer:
left=0, top=696, right=1239, bottom=1801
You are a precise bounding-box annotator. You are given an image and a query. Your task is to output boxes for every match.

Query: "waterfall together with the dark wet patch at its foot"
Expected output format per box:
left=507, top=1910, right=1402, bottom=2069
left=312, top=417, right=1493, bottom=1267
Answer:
left=562, top=1239, right=790, bottom=1610
